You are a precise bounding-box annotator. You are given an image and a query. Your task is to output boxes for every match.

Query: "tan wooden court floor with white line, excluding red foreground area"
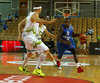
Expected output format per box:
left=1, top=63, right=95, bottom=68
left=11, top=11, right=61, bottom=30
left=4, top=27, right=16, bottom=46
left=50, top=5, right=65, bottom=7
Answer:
left=0, top=53, right=100, bottom=83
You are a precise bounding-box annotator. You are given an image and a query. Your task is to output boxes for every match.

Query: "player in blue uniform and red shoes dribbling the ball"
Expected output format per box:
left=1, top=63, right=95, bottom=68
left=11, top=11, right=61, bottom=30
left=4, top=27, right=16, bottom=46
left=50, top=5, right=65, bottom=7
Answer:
left=57, top=18, right=84, bottom=73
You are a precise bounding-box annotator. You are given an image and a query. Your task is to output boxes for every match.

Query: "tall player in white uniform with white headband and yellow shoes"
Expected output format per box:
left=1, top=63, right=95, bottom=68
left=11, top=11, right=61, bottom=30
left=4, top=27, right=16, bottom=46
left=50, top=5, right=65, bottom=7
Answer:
left=18, top=5, right=57, bottom=77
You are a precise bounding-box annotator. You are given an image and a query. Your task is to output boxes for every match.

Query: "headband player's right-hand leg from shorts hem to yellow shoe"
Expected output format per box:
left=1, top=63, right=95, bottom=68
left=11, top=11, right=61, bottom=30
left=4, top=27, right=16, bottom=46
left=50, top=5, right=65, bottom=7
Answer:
left=33, top=42, right=49, bottom=77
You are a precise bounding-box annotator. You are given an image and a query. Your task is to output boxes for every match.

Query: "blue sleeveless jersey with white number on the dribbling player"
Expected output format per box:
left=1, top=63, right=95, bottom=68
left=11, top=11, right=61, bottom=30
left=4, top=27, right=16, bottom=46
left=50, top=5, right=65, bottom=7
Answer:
left=57, top=24, right=75, bottom=49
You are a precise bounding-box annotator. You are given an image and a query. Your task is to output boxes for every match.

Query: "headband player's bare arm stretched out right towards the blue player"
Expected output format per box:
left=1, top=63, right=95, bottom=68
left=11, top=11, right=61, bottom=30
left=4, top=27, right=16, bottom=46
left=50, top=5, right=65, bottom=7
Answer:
left=31, top=13, right=58, bottom=24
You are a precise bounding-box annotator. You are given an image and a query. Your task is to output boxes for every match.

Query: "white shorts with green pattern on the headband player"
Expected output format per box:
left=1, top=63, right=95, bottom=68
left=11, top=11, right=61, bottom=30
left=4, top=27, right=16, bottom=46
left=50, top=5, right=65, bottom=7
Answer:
left=22, top=36, right=49, bottom=54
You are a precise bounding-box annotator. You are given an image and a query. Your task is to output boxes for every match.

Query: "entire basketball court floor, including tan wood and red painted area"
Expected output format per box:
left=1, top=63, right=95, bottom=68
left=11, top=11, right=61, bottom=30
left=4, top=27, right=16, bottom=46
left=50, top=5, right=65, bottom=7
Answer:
left=0, top=53, right=100, bottom=83
